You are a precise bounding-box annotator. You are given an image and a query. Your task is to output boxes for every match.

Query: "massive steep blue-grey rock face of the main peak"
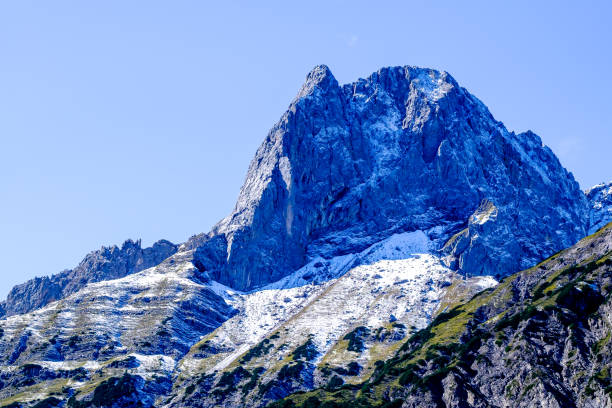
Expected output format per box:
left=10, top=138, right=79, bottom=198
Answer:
left=195, top=66, right=587, bottom=290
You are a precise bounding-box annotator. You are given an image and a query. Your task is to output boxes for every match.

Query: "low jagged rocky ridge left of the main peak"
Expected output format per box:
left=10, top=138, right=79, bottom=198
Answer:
left=0, top=240, right=178, bottom=317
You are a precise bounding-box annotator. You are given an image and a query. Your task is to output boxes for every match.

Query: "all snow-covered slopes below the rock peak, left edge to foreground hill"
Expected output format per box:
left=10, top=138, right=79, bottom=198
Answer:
left=0, top=229, right=495, bottom=406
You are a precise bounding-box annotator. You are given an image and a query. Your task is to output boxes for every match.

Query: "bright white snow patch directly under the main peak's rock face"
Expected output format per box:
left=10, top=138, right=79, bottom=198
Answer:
left=181, top=231, right=496, bottom=372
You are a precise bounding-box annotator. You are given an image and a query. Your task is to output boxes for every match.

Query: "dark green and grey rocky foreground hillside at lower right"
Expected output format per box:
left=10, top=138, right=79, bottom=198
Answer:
left=270, top=224, right=612, bottom=408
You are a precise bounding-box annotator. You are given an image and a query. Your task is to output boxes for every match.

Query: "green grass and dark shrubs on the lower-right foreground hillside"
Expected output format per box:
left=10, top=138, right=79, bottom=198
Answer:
left=269, top=224, right=612, bottom=408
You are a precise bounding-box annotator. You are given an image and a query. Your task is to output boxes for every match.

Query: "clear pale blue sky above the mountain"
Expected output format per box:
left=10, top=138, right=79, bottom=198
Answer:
left=0, top=0, right=612, bottom=298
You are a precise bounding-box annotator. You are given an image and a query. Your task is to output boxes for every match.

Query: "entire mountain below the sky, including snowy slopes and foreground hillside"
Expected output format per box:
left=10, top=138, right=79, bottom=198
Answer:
left=0, top=65, right=612, bottom=407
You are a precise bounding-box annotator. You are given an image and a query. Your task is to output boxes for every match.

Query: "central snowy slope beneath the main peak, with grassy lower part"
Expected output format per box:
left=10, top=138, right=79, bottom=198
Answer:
left=170, top=231, right=496, bottom=407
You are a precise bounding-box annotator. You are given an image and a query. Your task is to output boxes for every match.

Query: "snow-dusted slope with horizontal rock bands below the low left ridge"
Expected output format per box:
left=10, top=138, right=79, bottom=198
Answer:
left=0, top=251, right=235, bottom=403
